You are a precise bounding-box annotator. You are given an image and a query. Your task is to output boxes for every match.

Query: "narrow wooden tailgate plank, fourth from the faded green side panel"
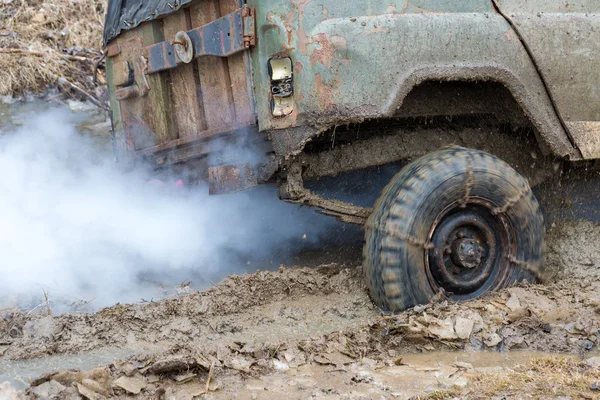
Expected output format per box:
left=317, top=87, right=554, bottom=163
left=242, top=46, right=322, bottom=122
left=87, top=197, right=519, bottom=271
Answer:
left=141, top=20, right=177, bottom=148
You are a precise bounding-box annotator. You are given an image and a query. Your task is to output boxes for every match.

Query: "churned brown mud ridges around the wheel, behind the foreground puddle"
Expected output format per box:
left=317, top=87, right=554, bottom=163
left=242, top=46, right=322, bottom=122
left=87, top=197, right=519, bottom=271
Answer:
left=0, top=222, right=600, bottom=396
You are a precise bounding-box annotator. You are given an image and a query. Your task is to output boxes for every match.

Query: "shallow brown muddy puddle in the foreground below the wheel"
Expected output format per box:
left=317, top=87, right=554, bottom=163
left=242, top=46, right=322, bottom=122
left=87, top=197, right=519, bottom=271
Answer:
left=229, top=351, right=596, bottom=400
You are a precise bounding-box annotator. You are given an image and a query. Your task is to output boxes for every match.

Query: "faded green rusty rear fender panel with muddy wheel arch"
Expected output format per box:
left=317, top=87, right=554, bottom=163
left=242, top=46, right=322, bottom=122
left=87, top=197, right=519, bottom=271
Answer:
left=248, top=0, right=580, bottom=158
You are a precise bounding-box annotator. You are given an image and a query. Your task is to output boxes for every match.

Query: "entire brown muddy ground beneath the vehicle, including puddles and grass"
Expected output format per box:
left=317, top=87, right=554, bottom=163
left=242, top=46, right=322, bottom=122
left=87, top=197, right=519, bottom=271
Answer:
left=0, top=222, right=600, bottom=399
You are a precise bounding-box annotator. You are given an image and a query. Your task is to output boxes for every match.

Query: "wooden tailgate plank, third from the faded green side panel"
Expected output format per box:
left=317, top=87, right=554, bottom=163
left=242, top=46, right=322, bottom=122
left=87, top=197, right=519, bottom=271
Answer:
left=163, top=9, right=206, bottom=137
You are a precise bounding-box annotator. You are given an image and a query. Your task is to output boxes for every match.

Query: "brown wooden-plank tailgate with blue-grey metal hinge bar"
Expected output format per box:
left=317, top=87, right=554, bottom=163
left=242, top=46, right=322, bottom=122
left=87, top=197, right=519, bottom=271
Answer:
left=107, top=0, right=256, bottom=162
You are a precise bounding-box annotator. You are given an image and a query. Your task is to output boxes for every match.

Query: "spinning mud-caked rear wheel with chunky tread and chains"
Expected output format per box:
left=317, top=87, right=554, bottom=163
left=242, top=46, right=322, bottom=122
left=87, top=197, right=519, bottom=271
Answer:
left=364, top=147, right=544, bottom=312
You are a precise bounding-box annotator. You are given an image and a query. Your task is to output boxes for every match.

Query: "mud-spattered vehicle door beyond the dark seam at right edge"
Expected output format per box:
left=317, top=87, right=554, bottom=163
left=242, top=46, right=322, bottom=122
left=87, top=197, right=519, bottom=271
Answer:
left=494, top=0, right=600, bottom=158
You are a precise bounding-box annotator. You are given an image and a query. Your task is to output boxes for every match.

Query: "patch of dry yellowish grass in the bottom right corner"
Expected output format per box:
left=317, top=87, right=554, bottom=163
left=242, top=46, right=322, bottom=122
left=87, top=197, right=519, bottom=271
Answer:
left=428, top=357, right=600, bottom=400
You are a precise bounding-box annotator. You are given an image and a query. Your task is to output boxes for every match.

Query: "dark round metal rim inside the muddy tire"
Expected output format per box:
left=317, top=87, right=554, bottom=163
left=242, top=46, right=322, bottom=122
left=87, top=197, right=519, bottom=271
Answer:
left=425, top=198, right=516, bottom=300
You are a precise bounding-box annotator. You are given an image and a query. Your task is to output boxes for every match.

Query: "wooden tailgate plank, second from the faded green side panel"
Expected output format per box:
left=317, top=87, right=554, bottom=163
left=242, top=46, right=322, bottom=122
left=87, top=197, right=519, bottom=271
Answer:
left=190, top=0, right=235, bottom=129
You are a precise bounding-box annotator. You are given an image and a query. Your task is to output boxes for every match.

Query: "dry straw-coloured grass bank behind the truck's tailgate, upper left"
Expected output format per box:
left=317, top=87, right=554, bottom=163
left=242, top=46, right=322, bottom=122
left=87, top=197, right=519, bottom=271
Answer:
left=0, top=0, right=106, bottom=95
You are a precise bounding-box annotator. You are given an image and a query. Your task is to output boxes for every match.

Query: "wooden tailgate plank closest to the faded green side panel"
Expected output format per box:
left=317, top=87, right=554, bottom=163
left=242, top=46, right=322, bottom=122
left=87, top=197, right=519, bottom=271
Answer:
left=220, top=0, right=254, bottom=123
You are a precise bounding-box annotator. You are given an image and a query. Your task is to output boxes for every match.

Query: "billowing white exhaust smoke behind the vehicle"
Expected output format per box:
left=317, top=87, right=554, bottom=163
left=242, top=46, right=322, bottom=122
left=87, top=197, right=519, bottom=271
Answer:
left=0, top=106, right=333, bottom=309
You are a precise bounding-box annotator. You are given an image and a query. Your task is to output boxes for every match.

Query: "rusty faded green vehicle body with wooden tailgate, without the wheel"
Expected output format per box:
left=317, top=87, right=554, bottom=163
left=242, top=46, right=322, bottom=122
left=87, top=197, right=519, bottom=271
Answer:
left=104, top=0, right=600, bottom=312
